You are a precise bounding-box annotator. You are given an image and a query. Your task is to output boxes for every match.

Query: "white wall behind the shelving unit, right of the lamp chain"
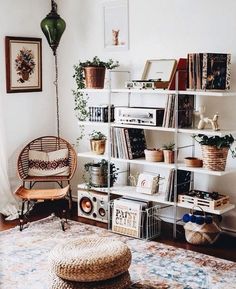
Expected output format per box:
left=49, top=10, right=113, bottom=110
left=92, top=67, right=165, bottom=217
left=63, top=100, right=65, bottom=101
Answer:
left=58, top=0, right=236, bottom=230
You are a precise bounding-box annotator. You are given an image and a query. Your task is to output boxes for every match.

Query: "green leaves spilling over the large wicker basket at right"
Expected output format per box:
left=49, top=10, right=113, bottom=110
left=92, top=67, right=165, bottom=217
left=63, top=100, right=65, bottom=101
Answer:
left=192, top=134, right=236, bottom=158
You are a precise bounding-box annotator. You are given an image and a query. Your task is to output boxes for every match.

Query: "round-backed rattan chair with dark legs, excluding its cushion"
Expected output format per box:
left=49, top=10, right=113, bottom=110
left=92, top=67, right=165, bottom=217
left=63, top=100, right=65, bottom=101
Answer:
left=16, top=136, right=77, bottom=230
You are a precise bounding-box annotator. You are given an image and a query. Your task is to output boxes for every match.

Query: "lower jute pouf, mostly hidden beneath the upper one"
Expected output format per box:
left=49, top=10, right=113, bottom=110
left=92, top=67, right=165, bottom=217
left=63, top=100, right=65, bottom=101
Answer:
left=50, top=272, right=131, bottom=289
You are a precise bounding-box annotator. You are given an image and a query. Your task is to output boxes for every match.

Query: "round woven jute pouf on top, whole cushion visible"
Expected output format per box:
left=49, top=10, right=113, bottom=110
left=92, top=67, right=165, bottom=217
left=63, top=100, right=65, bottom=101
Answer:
left=49, top=236, right=131, bottom=282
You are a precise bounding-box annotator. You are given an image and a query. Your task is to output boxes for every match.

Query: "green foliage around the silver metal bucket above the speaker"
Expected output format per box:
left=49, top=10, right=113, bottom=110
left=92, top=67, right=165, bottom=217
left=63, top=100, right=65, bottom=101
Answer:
left=83, top=159, right=119, bottom=188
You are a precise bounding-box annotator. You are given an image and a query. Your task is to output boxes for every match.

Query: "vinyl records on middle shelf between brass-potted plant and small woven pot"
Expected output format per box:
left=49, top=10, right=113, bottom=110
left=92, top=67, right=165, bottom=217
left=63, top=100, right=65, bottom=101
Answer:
left=111, top=127, right=147, bottom=160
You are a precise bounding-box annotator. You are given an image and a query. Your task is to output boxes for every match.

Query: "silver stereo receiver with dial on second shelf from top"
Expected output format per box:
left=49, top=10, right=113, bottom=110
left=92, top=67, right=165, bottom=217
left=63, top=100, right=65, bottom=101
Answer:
left=115, top=107, right=165, bottom=126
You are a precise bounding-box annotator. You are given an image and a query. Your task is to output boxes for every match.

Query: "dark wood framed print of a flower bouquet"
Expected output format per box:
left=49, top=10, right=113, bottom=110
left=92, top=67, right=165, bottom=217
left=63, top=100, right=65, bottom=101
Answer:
left=5, top=36, right=42, bottom=93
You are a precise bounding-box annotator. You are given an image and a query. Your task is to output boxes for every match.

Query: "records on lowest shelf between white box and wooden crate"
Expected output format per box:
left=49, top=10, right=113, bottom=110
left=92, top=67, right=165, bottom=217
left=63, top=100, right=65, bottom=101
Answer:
left=165, top=169, right=191, bottom=202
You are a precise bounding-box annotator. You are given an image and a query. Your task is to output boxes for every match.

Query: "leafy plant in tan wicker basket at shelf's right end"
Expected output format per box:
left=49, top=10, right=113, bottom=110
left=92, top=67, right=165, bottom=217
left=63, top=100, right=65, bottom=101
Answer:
left=193, top=134, right=236, bottom=171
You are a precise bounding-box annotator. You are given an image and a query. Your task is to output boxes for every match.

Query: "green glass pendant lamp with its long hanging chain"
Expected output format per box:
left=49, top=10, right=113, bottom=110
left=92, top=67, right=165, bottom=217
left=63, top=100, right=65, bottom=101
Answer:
left=40, top=0, right=66, bottom=137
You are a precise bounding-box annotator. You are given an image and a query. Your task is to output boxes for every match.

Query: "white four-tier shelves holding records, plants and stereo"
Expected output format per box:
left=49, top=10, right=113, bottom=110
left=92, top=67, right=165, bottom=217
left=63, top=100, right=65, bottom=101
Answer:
left=78, top=83, right=236, bottom=236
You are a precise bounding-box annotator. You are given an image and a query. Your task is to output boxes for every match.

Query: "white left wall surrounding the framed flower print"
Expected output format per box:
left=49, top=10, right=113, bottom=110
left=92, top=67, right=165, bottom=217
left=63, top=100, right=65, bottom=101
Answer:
left=0, top=0, right=55, bottom=190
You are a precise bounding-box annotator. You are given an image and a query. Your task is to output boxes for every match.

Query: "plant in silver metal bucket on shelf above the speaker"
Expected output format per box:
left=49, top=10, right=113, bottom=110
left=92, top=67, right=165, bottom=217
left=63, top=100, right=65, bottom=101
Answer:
left=84, top=159, right=119, bottom=188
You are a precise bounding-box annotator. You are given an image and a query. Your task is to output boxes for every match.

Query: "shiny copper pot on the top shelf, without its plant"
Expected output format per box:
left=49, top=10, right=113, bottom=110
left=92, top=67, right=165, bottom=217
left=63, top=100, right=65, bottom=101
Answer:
left=84, top=67, right=106, bottom=89
